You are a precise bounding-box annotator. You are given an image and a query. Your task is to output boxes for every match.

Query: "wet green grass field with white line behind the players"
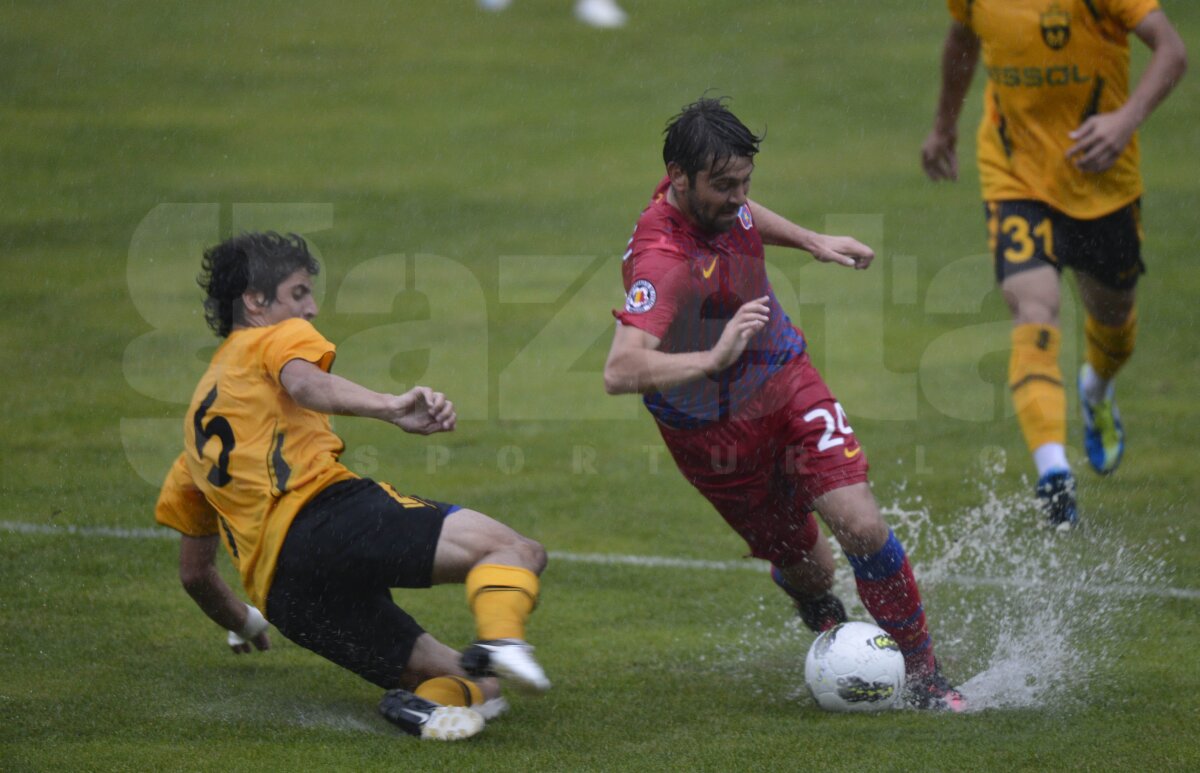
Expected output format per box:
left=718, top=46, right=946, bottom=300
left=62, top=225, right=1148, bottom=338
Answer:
left=0, top=0, right=1200, bottom=772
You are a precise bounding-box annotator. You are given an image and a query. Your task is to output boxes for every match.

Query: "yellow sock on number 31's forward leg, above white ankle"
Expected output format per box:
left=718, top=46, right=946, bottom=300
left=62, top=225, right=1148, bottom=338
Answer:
left=1008, top=324, right=1067, bottom=453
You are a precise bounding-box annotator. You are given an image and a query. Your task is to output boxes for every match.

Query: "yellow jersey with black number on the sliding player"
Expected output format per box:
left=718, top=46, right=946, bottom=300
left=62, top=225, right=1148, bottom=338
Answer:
left=155, top=318, right=358, bottom=613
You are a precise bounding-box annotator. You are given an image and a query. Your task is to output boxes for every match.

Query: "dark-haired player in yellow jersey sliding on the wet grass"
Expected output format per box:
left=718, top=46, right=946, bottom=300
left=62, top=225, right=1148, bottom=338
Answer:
left=155, top=233, right=550, bottom=741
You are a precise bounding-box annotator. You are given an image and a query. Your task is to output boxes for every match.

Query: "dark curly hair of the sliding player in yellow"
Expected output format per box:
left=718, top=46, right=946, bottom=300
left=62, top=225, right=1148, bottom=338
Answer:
left=196, top=230, right=320, bottom=338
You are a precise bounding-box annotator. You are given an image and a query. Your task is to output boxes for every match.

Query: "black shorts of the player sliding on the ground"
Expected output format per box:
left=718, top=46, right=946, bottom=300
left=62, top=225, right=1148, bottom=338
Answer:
left=266, top=478, right=458, bottom=689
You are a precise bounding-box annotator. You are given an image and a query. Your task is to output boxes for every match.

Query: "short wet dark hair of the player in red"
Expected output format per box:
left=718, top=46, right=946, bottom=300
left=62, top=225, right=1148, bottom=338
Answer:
left=662, top=97, right=763, bottom=182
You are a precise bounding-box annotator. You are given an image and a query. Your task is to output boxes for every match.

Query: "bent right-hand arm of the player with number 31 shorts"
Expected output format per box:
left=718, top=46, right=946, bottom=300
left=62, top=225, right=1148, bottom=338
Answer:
left=1067, top=11, right=1188, bottom=172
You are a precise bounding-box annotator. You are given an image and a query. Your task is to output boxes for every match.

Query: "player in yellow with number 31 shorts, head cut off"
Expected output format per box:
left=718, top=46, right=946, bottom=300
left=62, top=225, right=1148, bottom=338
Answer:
left=922, top=0, right=1187, bottom=528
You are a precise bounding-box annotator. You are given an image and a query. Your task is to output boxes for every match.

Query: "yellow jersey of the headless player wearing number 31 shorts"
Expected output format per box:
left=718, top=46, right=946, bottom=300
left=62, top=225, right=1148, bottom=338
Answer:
left=947, top=0, right=1159, bottom=220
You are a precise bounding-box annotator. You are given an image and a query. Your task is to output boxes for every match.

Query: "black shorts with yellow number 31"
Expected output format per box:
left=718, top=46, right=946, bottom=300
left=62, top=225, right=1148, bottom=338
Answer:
left=984, top=199, right=1146, bottom=290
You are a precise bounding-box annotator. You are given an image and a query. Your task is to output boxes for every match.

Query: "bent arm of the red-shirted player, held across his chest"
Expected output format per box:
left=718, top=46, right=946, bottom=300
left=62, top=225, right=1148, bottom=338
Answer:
left=604, top=296, right=769, bottom=395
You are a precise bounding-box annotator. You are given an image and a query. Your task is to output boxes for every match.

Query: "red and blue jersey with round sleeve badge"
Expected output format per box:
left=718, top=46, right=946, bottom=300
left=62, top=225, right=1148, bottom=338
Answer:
left=613, top=178, right=804, bottom=429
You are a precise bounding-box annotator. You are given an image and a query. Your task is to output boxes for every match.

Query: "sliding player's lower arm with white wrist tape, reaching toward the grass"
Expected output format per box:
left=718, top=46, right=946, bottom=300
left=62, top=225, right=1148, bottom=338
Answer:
left=179, top=534, right=271, bottom=653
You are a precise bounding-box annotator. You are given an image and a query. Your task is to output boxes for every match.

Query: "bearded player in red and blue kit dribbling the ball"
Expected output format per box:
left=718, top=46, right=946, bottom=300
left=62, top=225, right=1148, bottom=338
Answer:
left=605, top=98, right=965, bottom=711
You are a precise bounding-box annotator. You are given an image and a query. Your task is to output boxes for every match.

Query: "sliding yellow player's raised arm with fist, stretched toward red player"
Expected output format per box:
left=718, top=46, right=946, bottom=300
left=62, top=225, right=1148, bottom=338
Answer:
left=280, top=360, right=457, bottom=435
